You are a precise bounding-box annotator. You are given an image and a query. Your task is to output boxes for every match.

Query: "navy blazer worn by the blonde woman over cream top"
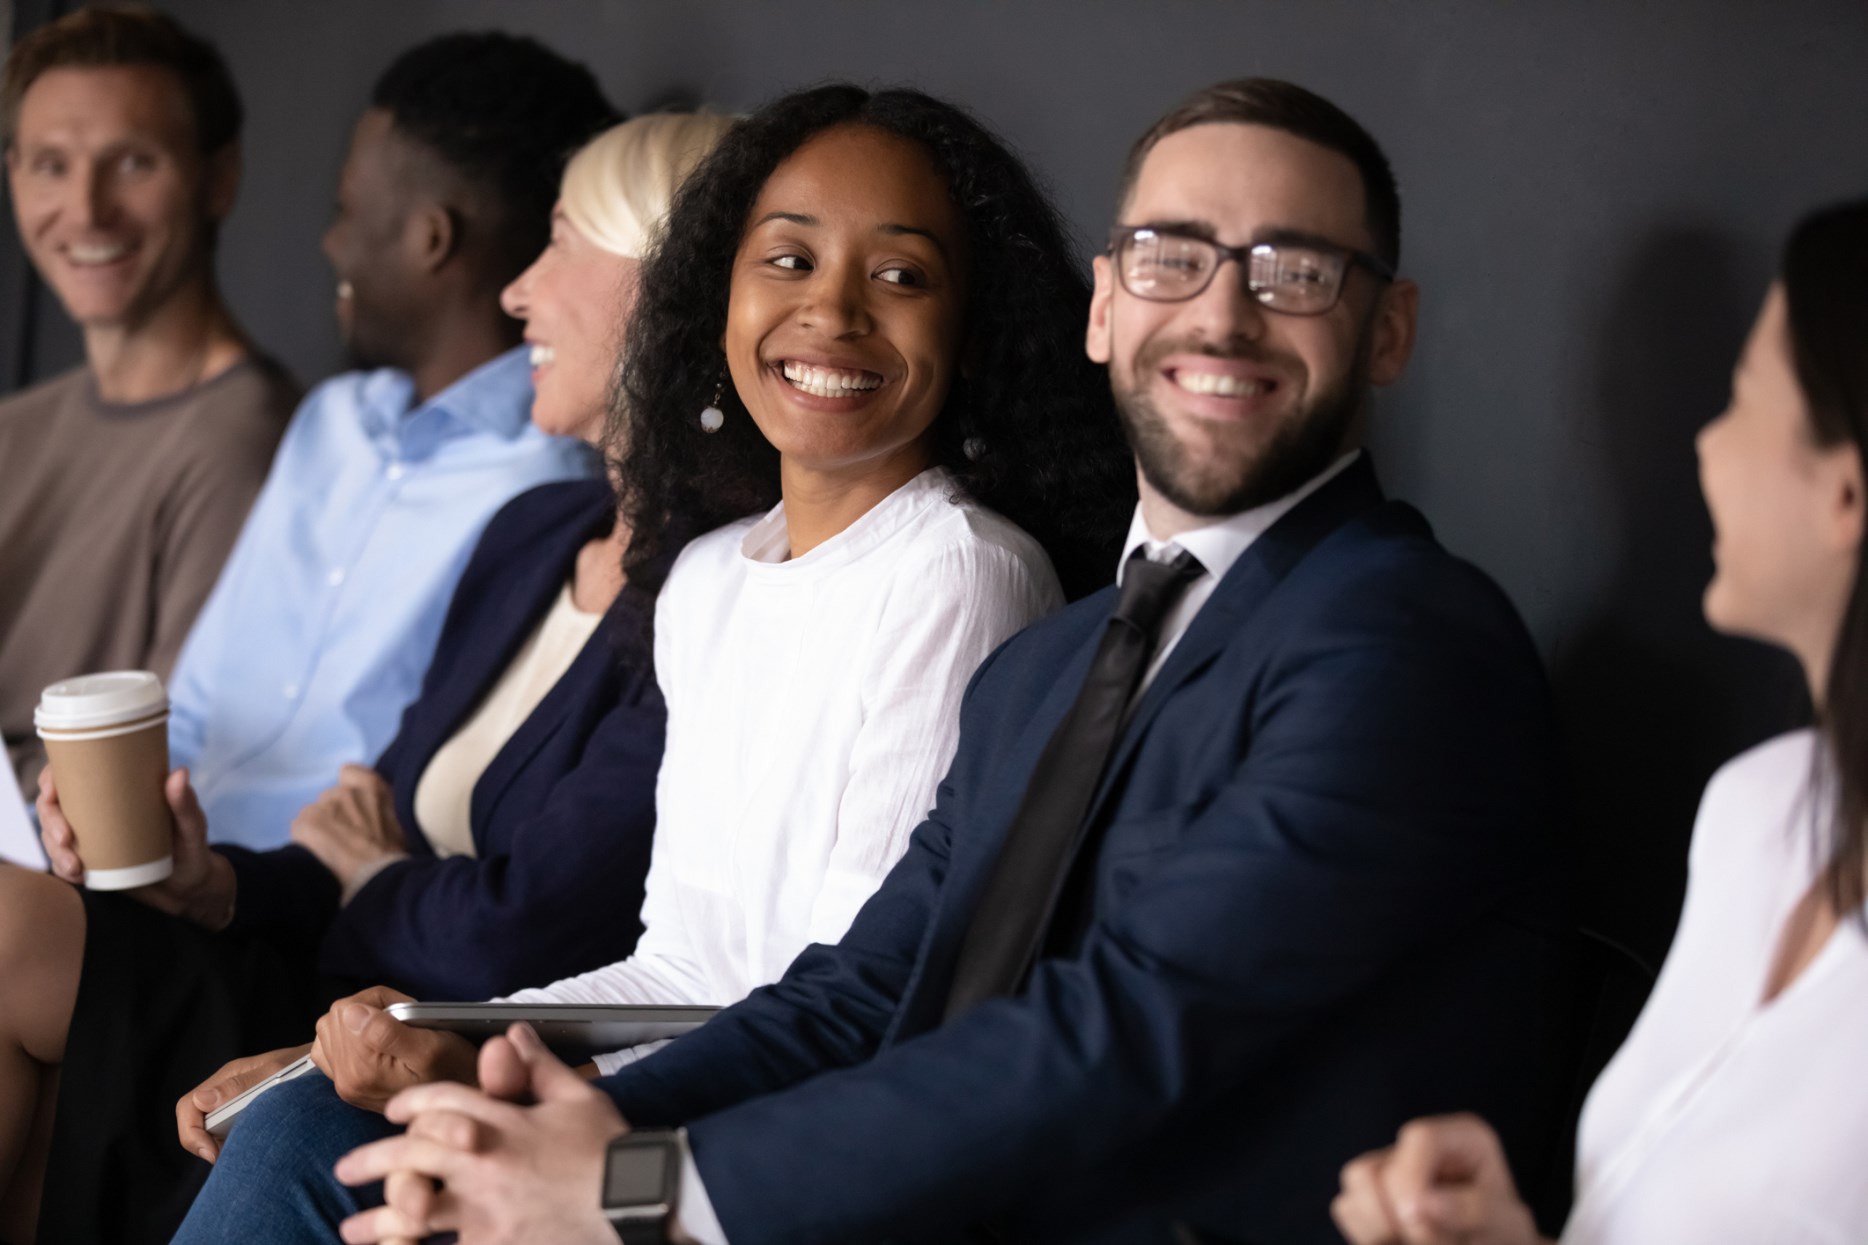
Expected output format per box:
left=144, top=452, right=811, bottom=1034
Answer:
left=217, top=480, right=665, bottom=998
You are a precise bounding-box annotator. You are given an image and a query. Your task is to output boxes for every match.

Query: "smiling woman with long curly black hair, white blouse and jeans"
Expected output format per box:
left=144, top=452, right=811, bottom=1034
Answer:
left=160, top=86, right=1134, bottom=1245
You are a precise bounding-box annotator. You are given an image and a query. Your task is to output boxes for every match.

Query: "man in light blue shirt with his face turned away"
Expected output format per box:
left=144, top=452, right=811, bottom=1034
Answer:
left=170, top=34, right=615, bottom=849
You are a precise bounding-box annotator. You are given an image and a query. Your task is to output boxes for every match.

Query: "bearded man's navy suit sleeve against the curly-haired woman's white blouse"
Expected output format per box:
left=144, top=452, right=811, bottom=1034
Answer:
left=598, top=637, right=1018, bottom=1127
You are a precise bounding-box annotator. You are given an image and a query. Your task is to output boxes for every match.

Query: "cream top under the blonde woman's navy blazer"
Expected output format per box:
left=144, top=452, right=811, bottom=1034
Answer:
left=415, top=581, right=603, bottom=856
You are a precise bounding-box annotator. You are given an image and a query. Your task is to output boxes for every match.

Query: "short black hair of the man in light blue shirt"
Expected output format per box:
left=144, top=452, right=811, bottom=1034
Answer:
left=370, top=30, right=624, bottom=275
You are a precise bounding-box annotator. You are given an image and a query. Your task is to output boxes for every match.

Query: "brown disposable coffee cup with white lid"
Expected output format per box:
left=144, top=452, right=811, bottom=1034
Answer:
left=32, top=669, right=176, bottom=890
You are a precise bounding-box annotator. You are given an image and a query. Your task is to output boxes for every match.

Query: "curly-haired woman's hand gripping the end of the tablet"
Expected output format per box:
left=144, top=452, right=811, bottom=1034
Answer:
left=312, top=985, right=474, bottom=1114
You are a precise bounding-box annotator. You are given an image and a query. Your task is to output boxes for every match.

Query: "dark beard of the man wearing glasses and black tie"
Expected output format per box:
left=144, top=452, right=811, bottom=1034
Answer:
left=1111, top=336, right=1369, bottom=518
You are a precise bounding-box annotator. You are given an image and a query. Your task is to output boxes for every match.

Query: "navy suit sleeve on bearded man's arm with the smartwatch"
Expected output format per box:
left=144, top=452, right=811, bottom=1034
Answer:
left=671, top=559, right=1552, bottom=1245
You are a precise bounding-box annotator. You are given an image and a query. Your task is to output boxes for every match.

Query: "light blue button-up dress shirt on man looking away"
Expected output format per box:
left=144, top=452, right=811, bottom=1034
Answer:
left=168, top=350, right=600, bottom=849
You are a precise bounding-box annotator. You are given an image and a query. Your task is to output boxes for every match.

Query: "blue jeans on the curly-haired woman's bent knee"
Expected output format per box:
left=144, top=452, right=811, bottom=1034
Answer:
left=172, top=1071, right=398, bottom=1245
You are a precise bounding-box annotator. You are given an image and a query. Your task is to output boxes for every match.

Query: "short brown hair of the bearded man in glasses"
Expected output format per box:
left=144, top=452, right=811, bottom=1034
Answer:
left=1115, top=79, right=1401, bottom=267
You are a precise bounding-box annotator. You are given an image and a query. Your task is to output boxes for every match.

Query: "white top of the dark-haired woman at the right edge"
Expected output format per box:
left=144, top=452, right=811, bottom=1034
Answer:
left=1564, top=731, right=1868, bottom=1245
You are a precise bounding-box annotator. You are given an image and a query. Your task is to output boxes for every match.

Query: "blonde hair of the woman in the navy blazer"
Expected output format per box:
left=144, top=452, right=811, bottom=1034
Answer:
left=559, top=112, right=740, bottom=260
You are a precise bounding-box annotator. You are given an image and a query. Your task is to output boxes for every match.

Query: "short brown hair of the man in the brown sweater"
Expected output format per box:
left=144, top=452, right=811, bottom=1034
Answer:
left=0, top=4, right=243, bottom=155
